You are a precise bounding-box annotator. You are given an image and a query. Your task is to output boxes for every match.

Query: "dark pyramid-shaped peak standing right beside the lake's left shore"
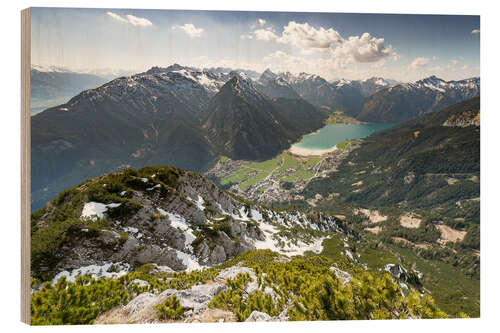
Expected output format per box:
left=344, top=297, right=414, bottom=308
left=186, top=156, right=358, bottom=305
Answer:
left=203, top=74, right=326, bottom=160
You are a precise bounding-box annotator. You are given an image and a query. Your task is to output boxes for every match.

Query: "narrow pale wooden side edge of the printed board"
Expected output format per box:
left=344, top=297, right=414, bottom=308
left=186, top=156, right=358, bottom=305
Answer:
left=21, top=8, right=31, bottom=325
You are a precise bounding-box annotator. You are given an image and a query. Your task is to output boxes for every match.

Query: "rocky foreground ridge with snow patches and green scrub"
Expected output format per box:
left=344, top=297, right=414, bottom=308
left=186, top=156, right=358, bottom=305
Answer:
left=32, top=167, right=346, bottom=280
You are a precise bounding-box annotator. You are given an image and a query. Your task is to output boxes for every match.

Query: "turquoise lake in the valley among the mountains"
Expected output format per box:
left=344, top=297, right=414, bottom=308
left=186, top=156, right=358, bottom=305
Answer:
left=294, top=123, right=396, bottom=150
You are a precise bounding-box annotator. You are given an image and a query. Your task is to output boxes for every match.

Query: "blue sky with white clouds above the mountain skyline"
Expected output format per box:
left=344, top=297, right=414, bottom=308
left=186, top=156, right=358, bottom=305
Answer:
left=31, top=8, right=480, bottom=81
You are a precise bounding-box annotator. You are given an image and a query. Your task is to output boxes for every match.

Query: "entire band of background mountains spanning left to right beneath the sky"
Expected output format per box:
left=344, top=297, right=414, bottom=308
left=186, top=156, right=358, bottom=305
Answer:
left=31, top=64, right=479, bottom=208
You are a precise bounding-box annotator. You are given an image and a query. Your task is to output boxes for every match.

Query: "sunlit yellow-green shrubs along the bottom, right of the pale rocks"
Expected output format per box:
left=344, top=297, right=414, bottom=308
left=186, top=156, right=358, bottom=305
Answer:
left=209, top=251, right=445, bottom=321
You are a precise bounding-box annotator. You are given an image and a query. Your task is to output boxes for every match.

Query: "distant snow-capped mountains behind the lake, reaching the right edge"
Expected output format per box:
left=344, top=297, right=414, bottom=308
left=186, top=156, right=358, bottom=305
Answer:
left=258, top=69, right=480, bottom=123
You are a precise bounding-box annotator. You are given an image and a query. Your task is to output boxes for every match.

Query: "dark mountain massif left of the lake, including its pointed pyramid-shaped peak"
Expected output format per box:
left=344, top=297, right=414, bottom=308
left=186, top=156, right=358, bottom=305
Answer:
left=31, top=64, right=327, bottom=207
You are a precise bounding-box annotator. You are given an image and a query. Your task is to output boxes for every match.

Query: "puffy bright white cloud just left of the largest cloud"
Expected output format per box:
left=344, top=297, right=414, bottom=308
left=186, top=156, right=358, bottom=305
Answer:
left=277, top=21, right=343, bottom=48
